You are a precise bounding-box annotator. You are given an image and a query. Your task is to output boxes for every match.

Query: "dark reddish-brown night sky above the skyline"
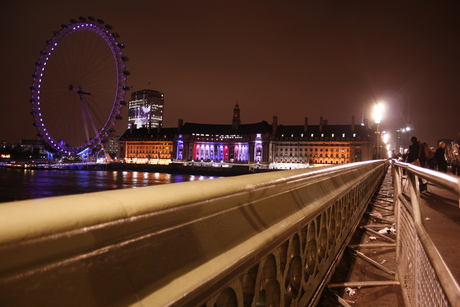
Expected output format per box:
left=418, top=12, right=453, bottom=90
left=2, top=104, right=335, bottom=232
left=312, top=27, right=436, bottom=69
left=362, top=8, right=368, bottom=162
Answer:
left=0, top=0, right=460, bottom=147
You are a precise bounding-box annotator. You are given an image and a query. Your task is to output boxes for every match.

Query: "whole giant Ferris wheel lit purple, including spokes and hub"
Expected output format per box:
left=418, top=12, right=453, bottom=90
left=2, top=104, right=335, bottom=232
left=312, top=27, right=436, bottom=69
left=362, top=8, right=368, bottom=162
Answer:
left=30, top=17, right=129, bottom=155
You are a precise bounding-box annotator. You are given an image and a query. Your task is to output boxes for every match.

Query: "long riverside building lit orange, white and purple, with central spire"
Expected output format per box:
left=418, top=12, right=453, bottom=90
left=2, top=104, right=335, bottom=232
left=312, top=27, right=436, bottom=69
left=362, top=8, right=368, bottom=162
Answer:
left=119, top=104, right=374, bottom=169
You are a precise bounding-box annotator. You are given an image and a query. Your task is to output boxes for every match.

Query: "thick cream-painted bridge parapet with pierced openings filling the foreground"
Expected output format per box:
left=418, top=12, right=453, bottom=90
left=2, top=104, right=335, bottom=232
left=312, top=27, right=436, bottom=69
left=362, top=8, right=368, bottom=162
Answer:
left=0, top=161, right=387, bottom=307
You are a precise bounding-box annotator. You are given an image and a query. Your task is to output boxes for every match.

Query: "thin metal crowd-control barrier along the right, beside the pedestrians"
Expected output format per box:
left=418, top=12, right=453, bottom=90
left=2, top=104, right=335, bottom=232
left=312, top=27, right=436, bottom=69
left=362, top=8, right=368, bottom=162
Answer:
left=393, top=162, right=460, bottom=307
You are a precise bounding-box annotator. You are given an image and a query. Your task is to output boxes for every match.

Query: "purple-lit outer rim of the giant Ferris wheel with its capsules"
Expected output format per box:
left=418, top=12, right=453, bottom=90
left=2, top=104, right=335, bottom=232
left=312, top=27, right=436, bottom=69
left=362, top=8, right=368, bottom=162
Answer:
left=30, top=17, right=129, bottom=154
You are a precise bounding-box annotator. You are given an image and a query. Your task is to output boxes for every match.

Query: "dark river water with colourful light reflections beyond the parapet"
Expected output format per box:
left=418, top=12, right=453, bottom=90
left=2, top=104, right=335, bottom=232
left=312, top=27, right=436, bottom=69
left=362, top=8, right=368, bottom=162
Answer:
left=0, top=167, right=219, bottom=203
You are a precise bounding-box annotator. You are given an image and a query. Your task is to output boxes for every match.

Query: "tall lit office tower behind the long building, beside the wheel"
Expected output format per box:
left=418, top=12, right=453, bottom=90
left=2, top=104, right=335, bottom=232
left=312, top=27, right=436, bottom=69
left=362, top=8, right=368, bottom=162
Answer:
left=128, top=90, right=164, bottom=129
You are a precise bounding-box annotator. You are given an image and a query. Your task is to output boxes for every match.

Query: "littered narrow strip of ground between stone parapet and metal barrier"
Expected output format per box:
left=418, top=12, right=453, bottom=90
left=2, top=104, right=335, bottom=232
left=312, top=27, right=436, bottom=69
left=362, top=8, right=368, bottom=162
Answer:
left=318, top=170, right=404, bottom=307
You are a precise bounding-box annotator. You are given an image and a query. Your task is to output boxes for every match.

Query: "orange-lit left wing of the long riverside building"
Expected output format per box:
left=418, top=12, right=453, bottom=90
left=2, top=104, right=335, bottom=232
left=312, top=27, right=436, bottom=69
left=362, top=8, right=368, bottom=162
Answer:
left=118, top=128, right=177, bottom=164
